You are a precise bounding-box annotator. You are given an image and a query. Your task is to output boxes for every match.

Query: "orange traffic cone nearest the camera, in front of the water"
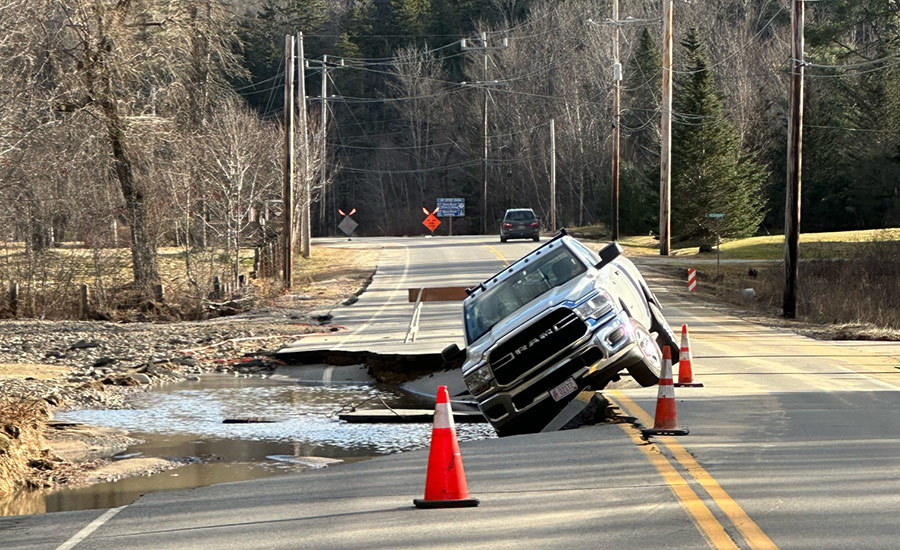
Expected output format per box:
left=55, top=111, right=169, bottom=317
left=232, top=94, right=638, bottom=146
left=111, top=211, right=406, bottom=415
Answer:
left=413, top=386, right=478, bottom=508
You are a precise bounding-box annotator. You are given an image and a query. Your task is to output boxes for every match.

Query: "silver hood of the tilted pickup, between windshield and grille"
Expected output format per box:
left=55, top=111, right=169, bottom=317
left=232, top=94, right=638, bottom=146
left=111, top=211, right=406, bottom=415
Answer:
left=467, top=271, right=599, bottom=363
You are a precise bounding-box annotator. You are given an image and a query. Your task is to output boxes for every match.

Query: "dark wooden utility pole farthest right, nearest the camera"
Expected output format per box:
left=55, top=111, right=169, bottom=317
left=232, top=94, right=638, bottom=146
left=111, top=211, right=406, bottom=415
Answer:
left=784, top=0, right=804, bottom=319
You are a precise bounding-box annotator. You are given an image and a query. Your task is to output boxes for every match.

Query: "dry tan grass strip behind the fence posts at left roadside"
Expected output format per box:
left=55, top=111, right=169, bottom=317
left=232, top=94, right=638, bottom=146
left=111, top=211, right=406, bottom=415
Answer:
left=0, top=243, right=378, bottom=320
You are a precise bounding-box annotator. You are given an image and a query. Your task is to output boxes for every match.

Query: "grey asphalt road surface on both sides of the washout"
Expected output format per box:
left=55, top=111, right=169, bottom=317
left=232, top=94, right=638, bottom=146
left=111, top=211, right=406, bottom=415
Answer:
left=0, top=237, right=900, bottom=550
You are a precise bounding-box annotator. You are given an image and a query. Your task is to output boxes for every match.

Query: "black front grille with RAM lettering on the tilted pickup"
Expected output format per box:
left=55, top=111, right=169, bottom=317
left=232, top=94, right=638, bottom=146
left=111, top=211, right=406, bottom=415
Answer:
left=488, top=308, right=587, bottom=384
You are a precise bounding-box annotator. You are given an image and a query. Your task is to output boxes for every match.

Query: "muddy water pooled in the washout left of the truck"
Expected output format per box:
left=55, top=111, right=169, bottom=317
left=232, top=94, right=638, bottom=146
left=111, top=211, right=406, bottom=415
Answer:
left=0, top=376, right=494, bottom=515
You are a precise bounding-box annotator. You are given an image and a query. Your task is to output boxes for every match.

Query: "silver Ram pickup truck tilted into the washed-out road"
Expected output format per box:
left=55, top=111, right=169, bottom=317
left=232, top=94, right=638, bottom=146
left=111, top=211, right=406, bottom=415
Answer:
left=443, top=230, right=678, bottom=436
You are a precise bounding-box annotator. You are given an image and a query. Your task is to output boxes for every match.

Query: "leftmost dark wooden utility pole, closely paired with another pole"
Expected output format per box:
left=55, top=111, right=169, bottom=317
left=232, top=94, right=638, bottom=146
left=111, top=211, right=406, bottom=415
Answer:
left=281, top=35, right=294, bottom=290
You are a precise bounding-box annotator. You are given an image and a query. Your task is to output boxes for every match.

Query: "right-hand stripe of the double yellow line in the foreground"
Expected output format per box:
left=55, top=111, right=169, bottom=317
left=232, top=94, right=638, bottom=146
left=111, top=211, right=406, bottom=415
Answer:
left=607, top=390, right=778, bottom=550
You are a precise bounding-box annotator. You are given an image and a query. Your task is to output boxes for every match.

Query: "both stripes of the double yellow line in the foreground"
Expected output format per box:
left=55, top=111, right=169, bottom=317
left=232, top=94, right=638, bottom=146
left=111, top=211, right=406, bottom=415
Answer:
left=604, top=390, right=778, bottom=550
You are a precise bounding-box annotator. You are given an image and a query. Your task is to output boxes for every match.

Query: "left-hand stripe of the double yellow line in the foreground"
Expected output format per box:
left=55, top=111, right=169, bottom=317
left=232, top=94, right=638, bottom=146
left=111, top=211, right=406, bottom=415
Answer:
left=619, top=424, right=738, bottom=550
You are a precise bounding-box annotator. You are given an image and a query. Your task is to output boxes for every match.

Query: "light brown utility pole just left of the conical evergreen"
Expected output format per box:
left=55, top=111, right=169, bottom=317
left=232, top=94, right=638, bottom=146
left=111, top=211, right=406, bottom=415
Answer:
left=659, top=0, right=673, bottom=256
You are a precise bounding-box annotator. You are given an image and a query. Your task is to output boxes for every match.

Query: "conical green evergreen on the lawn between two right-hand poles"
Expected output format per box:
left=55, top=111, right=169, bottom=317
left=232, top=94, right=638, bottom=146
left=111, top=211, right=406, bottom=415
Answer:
left=672, top=29, right=766, bottom=240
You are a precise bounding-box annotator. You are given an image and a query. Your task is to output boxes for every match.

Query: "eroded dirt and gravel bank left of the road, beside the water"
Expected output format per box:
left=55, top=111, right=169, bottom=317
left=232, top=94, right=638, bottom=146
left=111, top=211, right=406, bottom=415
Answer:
left=0, top=246, right=378, bottom=497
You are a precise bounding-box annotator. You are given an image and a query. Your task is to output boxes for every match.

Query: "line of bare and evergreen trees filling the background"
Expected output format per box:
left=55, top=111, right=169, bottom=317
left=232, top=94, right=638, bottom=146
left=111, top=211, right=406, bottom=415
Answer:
left=0, top=0, right=900, bottom=298
